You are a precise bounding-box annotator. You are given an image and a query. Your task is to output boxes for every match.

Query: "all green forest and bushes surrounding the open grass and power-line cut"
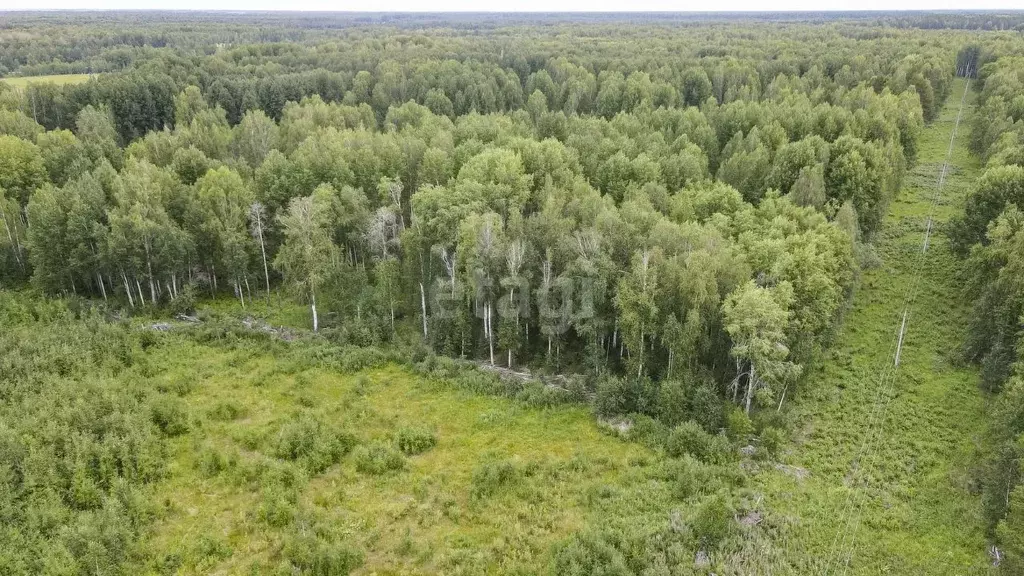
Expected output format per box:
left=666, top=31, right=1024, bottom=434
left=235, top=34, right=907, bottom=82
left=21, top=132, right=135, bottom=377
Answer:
left=0, top=12, right=1024, bottom=575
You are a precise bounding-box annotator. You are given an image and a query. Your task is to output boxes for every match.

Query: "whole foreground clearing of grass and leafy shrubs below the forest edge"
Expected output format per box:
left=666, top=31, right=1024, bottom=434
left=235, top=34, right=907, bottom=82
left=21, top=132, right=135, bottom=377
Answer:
left=0, top=291, right=776, bottom=576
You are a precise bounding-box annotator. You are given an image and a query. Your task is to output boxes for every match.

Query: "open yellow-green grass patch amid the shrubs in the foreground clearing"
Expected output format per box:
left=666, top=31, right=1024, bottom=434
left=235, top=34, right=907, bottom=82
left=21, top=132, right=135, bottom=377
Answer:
left=132, top=337, right=664, bottom=574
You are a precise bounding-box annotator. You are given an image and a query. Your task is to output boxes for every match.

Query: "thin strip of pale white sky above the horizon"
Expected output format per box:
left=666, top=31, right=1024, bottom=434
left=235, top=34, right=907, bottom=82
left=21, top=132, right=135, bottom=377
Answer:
left=0, top=0, right=1024, bottom=11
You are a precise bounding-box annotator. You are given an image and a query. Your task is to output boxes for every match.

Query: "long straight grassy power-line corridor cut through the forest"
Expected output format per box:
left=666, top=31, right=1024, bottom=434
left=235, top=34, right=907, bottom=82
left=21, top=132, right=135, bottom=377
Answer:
left=757, top=81, right=989, bottom=575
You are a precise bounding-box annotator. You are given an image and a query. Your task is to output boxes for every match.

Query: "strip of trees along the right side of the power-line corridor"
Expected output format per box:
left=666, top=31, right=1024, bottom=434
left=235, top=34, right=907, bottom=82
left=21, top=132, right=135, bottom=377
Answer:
left=950, top=43, right=1024, bottom=573
